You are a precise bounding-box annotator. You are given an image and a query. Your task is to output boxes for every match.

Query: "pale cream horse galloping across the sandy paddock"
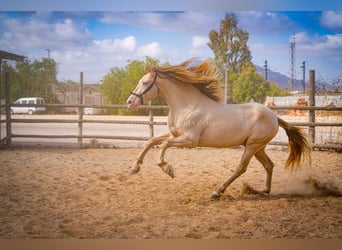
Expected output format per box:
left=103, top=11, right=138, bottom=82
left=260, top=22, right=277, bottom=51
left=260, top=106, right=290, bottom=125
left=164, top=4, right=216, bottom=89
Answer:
left=126, top=59, right=311, bottom=199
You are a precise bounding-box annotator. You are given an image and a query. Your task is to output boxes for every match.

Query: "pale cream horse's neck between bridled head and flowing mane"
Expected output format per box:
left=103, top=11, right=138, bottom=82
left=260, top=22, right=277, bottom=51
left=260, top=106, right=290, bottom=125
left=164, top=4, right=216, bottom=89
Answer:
left=159, top=80, right=206, bottom=112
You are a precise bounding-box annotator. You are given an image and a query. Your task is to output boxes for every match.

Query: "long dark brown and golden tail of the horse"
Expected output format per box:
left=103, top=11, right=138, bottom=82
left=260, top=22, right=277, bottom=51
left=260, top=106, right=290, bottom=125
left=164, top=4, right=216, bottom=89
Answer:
left=278, top=117, right=311, bottom=170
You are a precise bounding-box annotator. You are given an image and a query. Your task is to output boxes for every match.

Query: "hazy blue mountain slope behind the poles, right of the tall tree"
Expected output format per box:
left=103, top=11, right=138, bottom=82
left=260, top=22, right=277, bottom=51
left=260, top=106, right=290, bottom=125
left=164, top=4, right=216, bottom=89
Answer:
left=255, top=65, right=307, bottom=91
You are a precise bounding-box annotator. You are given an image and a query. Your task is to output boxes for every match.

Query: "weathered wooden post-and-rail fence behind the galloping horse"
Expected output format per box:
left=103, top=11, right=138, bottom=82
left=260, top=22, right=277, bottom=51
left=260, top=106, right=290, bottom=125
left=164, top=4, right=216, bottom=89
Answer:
left=0, top=71, right=342, bottom=150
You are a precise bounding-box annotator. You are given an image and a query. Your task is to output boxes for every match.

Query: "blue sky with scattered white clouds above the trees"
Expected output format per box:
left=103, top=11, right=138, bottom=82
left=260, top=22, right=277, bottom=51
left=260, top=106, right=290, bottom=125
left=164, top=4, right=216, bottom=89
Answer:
left=0, top=1, right=342, bottom=83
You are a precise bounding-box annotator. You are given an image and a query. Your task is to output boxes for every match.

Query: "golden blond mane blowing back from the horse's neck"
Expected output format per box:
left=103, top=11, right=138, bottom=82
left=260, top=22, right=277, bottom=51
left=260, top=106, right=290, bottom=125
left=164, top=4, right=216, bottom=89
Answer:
left=151, top=58, right=223, bottom=102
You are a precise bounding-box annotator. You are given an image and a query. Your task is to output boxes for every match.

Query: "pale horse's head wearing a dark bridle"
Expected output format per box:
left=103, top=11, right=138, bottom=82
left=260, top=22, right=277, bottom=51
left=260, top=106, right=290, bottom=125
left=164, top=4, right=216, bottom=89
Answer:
left=126, top=72, right=159, bottom=110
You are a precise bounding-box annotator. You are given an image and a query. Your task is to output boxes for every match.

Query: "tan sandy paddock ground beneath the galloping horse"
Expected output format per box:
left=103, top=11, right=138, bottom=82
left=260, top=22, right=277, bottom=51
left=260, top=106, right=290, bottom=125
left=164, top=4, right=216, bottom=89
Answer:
left=0, top=148, right=342, bottom=239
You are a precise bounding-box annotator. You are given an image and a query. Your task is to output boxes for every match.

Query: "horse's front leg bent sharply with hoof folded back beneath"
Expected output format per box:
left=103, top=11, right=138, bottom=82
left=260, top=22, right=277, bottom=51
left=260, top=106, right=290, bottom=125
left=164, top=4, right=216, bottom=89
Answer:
left=158, top=135, right=197, bottom=178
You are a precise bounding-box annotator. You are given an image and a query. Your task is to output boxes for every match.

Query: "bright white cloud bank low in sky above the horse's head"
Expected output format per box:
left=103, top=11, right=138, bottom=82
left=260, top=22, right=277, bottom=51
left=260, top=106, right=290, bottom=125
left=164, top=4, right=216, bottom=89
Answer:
left=52, top=36, right=167, bottom=83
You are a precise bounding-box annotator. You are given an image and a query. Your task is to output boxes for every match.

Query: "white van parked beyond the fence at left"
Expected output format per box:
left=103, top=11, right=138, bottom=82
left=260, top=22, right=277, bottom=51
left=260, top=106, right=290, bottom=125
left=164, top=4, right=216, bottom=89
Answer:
left=11, top=97, right=46, bottom=115
